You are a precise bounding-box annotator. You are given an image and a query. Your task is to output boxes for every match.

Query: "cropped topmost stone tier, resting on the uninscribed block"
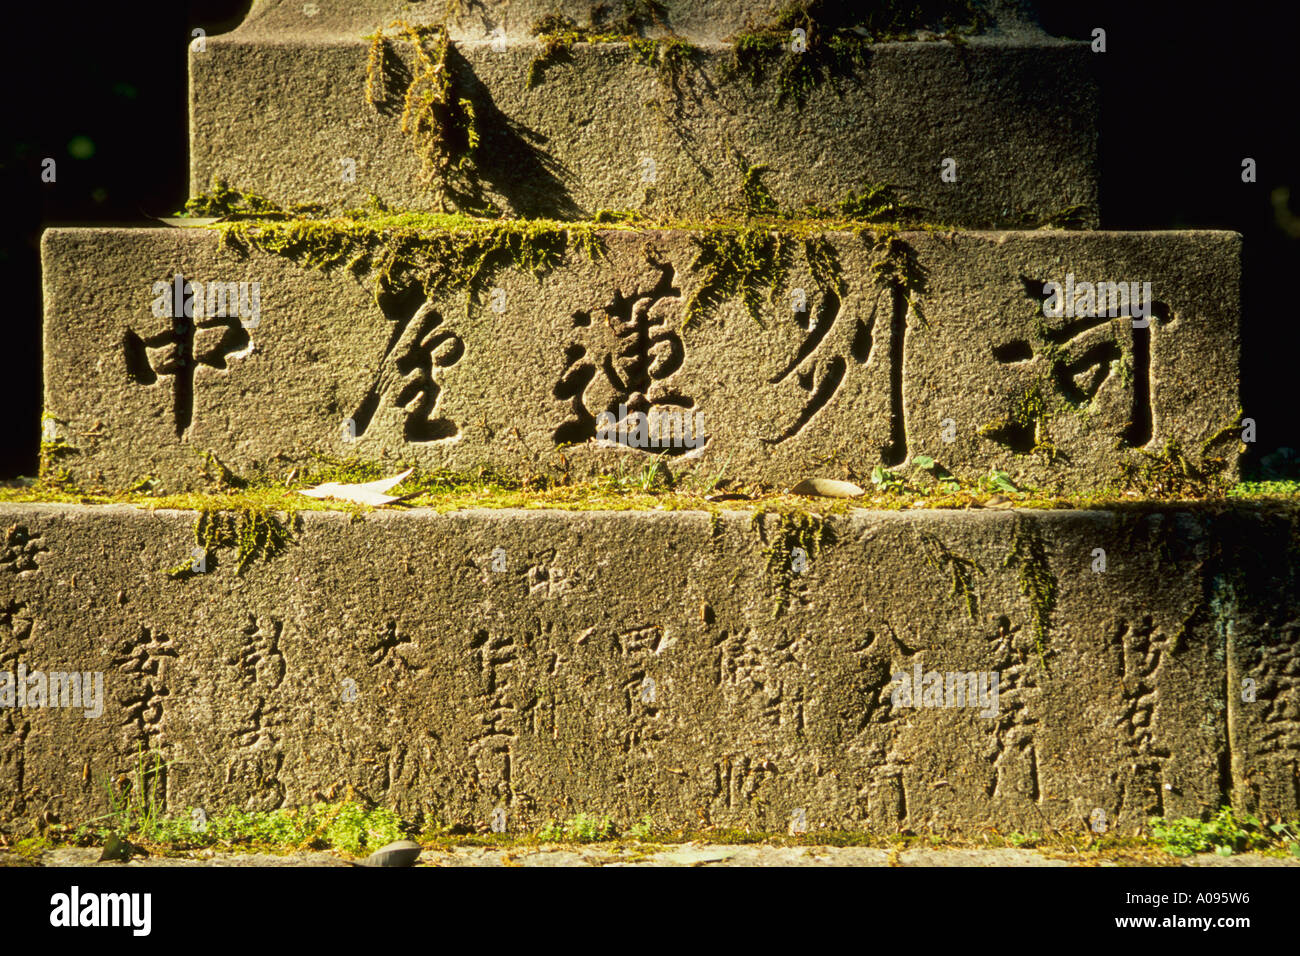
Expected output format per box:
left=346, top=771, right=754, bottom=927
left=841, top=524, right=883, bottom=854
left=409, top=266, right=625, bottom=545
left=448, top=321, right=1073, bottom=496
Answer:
left=238, top=0, right=1041, bottom=43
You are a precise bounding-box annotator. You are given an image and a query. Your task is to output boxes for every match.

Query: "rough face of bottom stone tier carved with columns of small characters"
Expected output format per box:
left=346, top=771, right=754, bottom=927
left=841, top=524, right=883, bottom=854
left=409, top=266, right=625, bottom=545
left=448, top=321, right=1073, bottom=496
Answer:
left=0, top=505, right=1300, bottom=832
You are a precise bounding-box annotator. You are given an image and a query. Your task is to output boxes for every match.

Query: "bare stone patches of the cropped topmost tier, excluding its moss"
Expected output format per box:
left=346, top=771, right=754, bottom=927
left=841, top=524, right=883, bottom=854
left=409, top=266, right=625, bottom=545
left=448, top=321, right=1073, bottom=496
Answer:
left=238, top=0, right=1040, bottom=40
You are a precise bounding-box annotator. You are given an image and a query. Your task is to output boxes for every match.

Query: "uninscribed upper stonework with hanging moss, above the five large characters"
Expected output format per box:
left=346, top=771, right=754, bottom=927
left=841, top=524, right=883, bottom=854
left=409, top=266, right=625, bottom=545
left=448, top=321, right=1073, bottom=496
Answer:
left=190, top=0, right=1099, bottom=222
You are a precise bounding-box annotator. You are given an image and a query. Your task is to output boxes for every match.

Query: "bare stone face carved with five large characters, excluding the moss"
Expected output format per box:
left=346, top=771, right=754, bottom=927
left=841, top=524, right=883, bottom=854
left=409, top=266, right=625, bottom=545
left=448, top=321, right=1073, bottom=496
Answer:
left=43, top=229, right=1240, bottom=489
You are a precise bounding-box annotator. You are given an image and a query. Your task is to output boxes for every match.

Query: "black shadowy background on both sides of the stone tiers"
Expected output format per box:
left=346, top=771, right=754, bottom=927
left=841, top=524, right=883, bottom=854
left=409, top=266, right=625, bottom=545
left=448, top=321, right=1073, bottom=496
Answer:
left=0, top=0, right=1300, bottom=477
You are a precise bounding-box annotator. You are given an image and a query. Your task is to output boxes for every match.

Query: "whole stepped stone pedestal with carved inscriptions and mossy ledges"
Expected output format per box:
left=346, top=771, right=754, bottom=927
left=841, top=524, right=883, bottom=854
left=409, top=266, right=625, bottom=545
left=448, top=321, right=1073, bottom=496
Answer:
left=0, top=0, right=1300, bottom=832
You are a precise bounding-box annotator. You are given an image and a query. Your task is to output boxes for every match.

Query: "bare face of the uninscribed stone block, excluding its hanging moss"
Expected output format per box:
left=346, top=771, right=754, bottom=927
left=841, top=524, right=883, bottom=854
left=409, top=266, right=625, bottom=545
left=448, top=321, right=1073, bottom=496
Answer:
left=190, top=31, right=1097, bottom=228
